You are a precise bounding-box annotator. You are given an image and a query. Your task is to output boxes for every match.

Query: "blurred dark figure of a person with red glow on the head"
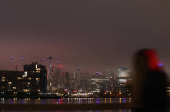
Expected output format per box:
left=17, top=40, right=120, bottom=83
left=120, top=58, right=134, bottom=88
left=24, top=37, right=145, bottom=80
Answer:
left=132, top=49, right=167, bottom=112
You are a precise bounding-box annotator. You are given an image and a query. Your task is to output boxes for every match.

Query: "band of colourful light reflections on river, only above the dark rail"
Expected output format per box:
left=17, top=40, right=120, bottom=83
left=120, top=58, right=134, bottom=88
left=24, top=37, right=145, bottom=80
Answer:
left=0, top=98, right=131, bottom=104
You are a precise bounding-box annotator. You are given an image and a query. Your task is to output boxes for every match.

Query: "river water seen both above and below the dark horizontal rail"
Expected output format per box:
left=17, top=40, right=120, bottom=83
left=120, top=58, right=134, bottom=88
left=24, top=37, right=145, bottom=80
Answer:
left=0, top=98, right=131, bottom=112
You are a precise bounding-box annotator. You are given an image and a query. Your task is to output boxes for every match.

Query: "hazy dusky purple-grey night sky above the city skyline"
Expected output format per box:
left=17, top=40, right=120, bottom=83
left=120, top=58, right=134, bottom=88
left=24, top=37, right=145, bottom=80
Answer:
left=0, top=0, right=170, bottom=73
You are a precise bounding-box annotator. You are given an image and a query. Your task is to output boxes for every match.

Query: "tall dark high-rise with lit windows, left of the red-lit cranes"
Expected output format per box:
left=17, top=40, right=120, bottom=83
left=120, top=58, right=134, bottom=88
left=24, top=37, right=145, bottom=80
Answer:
left=24, top=62, right=47, bottom=93
